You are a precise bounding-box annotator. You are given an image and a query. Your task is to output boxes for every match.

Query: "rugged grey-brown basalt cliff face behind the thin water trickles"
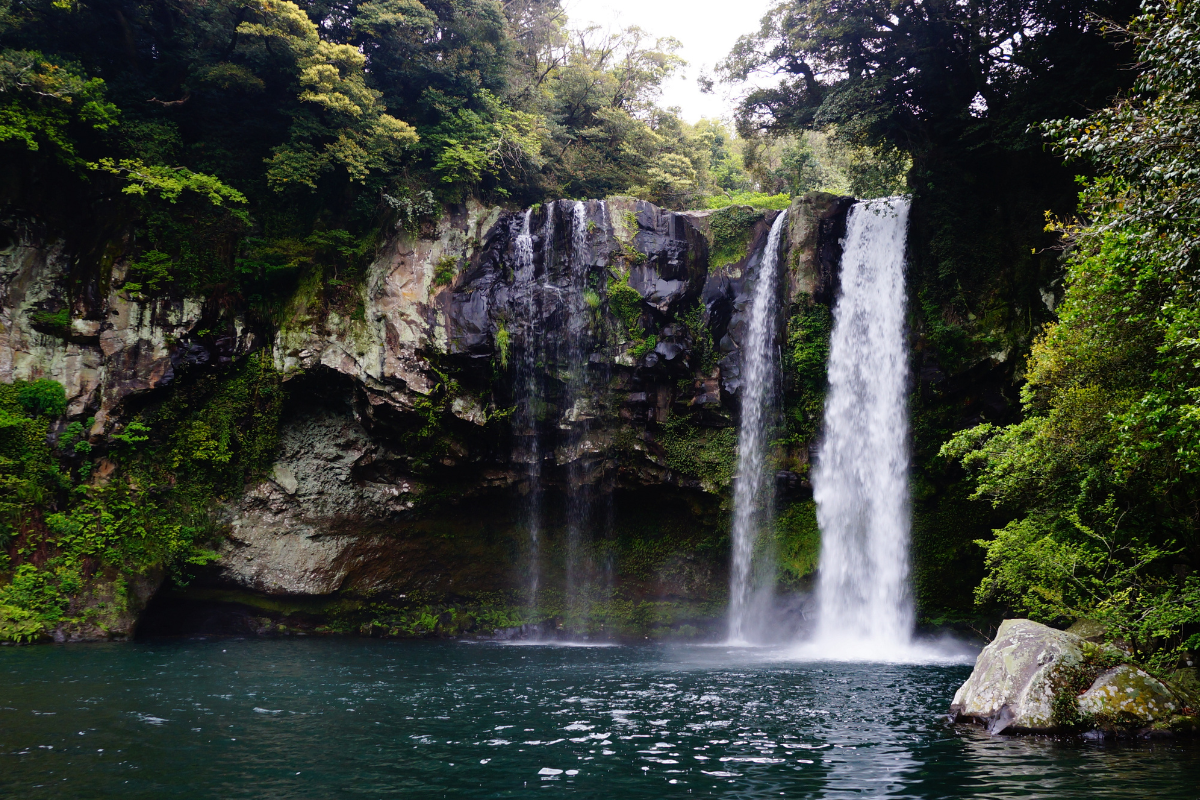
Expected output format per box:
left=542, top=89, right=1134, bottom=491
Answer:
left=0, top=194, right=851, bottom=638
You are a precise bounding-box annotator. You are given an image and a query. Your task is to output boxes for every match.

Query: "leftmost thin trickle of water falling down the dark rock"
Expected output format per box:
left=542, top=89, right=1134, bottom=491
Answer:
left=512, top=209, right=541, bottom=610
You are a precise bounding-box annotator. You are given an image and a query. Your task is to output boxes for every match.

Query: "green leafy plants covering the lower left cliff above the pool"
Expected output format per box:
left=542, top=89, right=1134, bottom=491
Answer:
left=0, top=353, right=282, bottom=640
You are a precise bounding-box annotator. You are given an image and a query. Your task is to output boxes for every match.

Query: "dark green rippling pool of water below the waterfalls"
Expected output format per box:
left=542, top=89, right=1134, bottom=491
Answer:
left=0, top=639, right=1200, bottom=800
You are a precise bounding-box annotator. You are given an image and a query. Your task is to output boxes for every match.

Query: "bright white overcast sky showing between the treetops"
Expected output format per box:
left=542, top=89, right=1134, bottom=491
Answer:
left=563, top=0, right=772, bottom=122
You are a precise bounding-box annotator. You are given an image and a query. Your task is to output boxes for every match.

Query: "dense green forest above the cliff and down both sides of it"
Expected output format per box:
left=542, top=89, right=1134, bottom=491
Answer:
left=0, top=0, right=1200, bottom=669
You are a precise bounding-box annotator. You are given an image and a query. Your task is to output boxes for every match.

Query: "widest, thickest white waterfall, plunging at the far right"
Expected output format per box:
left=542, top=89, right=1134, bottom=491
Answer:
left=812, top=197, right=913, bottom=658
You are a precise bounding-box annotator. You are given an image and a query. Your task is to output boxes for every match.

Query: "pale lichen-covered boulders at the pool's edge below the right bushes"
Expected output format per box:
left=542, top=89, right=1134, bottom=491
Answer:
left=950, top=619, right=1195, bottom=734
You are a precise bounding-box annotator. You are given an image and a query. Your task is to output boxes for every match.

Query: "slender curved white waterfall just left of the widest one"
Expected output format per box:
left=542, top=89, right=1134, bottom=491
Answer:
left=728, top=211, right=787, bottom=642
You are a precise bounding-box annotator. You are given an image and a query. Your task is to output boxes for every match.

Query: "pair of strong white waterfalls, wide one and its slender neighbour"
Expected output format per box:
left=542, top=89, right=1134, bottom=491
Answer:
left=728, top=198, right=913, bottom=660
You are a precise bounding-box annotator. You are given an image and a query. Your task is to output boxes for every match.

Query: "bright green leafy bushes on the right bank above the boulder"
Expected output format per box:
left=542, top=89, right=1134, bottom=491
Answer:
left=943, top=4, right=1200, bottom=670
